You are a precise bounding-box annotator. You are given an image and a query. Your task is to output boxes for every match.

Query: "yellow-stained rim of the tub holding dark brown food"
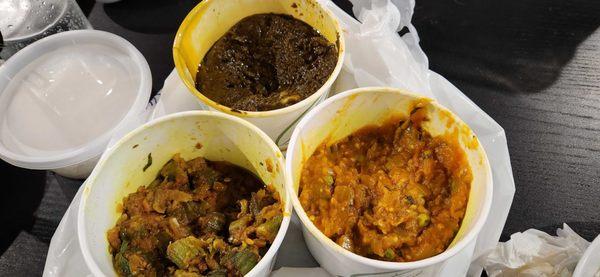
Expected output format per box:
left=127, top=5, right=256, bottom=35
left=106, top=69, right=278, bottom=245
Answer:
left=173, top=0, right=346, bottom=118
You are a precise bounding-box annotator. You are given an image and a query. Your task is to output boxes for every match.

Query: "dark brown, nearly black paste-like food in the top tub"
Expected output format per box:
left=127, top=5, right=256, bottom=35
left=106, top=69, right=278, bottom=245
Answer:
left=196, top=14, right=338, bottom=111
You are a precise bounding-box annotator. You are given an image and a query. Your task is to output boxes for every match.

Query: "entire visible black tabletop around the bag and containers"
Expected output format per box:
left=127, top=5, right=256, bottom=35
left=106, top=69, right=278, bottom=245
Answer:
left=0, top=0, right=600, bottom=276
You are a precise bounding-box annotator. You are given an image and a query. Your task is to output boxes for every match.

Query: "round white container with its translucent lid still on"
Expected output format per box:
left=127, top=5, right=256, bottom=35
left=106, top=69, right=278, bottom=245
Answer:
left=0, top=30, right=152, bottom=178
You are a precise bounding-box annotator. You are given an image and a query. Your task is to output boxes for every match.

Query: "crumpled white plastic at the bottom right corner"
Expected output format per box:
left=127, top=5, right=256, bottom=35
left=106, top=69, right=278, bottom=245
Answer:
left=477, top=224, right=590, bottom=277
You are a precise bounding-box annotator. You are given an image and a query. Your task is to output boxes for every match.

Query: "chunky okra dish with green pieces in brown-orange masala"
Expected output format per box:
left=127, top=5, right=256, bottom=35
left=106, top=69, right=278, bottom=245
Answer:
left=107, top=155, right=283, bottom=276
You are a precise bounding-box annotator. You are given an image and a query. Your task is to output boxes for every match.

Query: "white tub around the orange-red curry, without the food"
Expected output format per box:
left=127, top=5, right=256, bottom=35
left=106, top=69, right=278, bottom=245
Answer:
left=286, top=88, right=493, bottom=276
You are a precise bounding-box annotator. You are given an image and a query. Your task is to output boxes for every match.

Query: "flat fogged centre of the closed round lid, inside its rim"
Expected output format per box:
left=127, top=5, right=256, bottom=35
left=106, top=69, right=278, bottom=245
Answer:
left=1, top=44, right=139, bottom=156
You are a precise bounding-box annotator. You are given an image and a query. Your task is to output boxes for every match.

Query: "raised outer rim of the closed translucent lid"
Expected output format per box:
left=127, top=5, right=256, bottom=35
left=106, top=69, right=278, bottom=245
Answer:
left=0, top=30, right=152, bottom=170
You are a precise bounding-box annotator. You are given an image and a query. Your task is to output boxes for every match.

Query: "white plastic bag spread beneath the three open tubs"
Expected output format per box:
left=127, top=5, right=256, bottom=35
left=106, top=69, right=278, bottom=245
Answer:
left=44, top=0, right=515, bottom=276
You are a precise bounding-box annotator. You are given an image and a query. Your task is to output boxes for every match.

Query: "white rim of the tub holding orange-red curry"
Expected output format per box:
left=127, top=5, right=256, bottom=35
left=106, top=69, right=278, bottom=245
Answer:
left=285, top=87, right=493, bottom=270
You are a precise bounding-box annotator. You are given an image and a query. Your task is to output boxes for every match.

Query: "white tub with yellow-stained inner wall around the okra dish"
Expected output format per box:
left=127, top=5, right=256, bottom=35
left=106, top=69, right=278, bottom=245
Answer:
left=77, top=111, right=292, bottom=276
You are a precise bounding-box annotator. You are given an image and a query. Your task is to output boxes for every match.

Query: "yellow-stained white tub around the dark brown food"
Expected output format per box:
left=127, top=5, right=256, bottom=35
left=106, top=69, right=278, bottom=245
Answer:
left=173, top=0, right=346, bottom=146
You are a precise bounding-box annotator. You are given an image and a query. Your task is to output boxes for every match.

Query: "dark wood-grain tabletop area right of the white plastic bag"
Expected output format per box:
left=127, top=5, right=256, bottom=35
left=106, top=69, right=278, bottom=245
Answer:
left=413, top=0, right=600, bottom=237
